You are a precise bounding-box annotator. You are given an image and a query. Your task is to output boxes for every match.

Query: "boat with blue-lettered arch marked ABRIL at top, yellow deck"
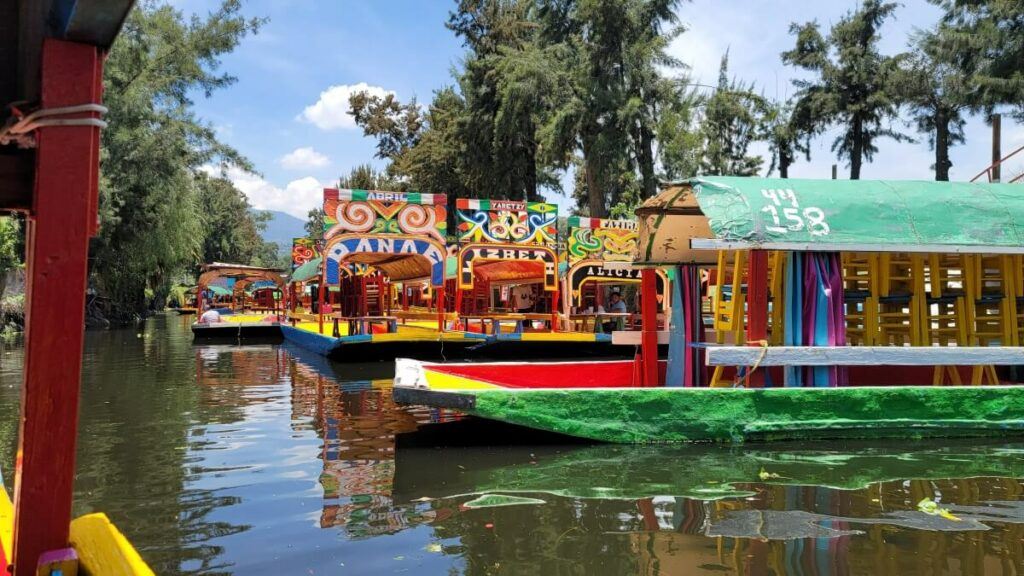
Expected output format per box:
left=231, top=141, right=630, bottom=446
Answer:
left=282, top=189, right=485, bottom=361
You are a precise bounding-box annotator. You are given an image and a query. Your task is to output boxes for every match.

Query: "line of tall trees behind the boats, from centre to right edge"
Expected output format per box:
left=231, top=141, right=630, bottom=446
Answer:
left=349, top=0, right=1024, bottom=216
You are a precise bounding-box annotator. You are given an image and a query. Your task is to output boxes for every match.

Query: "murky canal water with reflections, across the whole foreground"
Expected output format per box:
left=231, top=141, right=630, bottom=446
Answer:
left=0, top=315, right=1024, bottom=576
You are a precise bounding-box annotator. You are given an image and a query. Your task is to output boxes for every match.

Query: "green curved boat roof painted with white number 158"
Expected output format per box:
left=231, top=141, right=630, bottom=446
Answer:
left=637, top=176, right=1024, bottom=259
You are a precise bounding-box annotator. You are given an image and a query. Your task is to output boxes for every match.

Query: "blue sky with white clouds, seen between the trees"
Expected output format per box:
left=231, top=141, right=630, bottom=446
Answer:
left=172, top=0, right=1024, bottom=218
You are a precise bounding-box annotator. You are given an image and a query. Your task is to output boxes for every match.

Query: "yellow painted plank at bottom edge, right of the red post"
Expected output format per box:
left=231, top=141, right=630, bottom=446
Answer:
left=71, top=513, right=155, bottom=576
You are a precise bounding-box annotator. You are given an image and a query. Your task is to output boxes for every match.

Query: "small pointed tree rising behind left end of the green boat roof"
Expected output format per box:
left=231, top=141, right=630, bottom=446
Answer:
left=700, top=52, right=764, bottom=176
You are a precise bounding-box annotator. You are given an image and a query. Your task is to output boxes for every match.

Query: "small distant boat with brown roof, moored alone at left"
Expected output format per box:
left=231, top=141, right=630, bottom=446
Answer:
left=191, top=262, right=286, bottom=339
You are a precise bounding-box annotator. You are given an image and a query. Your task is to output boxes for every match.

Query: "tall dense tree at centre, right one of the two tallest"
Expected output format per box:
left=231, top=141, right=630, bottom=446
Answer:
left=538, top=0, right=681, bottom=216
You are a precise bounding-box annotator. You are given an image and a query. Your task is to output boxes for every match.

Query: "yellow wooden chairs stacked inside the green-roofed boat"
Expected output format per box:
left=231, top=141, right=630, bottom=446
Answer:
left=709, top=251, right=1024, bottom=384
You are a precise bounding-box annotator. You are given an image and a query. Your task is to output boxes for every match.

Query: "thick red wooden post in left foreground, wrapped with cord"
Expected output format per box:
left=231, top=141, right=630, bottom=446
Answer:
left=12, top=40, right=102, bottom=576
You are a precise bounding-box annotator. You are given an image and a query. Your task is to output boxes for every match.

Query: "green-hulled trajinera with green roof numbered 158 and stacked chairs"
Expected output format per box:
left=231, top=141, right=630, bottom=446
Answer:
left=394, top=176, right=1024, bottom=443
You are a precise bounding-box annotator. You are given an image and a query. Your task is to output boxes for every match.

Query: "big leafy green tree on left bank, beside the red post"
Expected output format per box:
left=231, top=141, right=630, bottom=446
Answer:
left=91, top=0, right=261, bottom=317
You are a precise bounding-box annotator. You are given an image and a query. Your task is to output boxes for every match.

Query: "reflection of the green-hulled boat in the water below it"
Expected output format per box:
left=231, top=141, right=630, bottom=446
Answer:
left=395, top=442, right=1024, bottom=575
